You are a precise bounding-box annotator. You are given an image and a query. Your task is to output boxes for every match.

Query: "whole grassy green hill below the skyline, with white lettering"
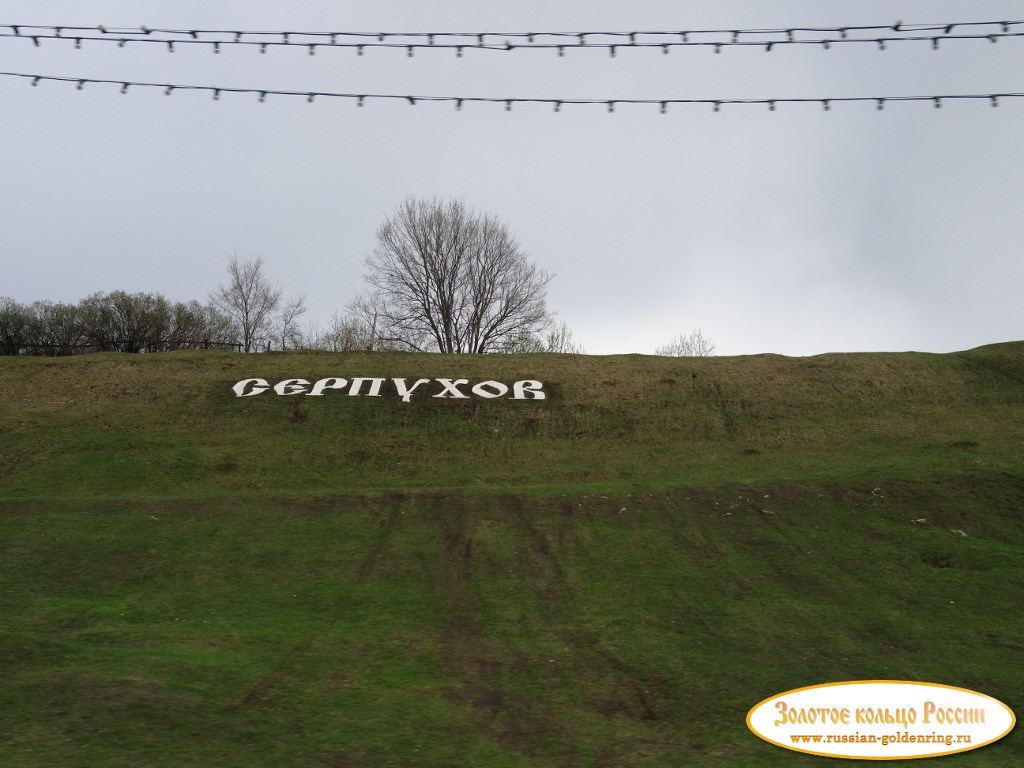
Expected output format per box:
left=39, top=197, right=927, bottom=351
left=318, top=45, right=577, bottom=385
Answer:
left=0, top=343, right=1024, bottom=768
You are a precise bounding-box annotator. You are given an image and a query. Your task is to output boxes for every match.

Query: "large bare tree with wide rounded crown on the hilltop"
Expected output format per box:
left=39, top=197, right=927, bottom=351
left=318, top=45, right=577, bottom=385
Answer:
left=357, top=198, right=551, bottom=353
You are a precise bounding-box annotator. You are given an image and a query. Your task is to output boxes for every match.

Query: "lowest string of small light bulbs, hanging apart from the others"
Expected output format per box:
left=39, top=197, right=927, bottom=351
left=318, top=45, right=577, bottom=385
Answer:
left=6, top=72, right=1024, bottom=114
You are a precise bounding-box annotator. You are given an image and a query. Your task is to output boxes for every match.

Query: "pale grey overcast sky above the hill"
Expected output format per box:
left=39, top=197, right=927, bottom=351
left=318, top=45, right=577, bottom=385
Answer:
left=0, top=0, right=1024, bottom=355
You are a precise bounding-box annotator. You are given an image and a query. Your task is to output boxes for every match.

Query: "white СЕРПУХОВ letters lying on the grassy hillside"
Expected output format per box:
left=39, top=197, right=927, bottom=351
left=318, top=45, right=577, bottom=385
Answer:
left=231, top=377, right=547, bottom=402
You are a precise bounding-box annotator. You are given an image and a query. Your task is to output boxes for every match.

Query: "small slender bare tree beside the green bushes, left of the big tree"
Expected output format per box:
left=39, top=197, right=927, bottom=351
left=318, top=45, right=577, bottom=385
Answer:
left=210, top=254, right=281, bottom=352
